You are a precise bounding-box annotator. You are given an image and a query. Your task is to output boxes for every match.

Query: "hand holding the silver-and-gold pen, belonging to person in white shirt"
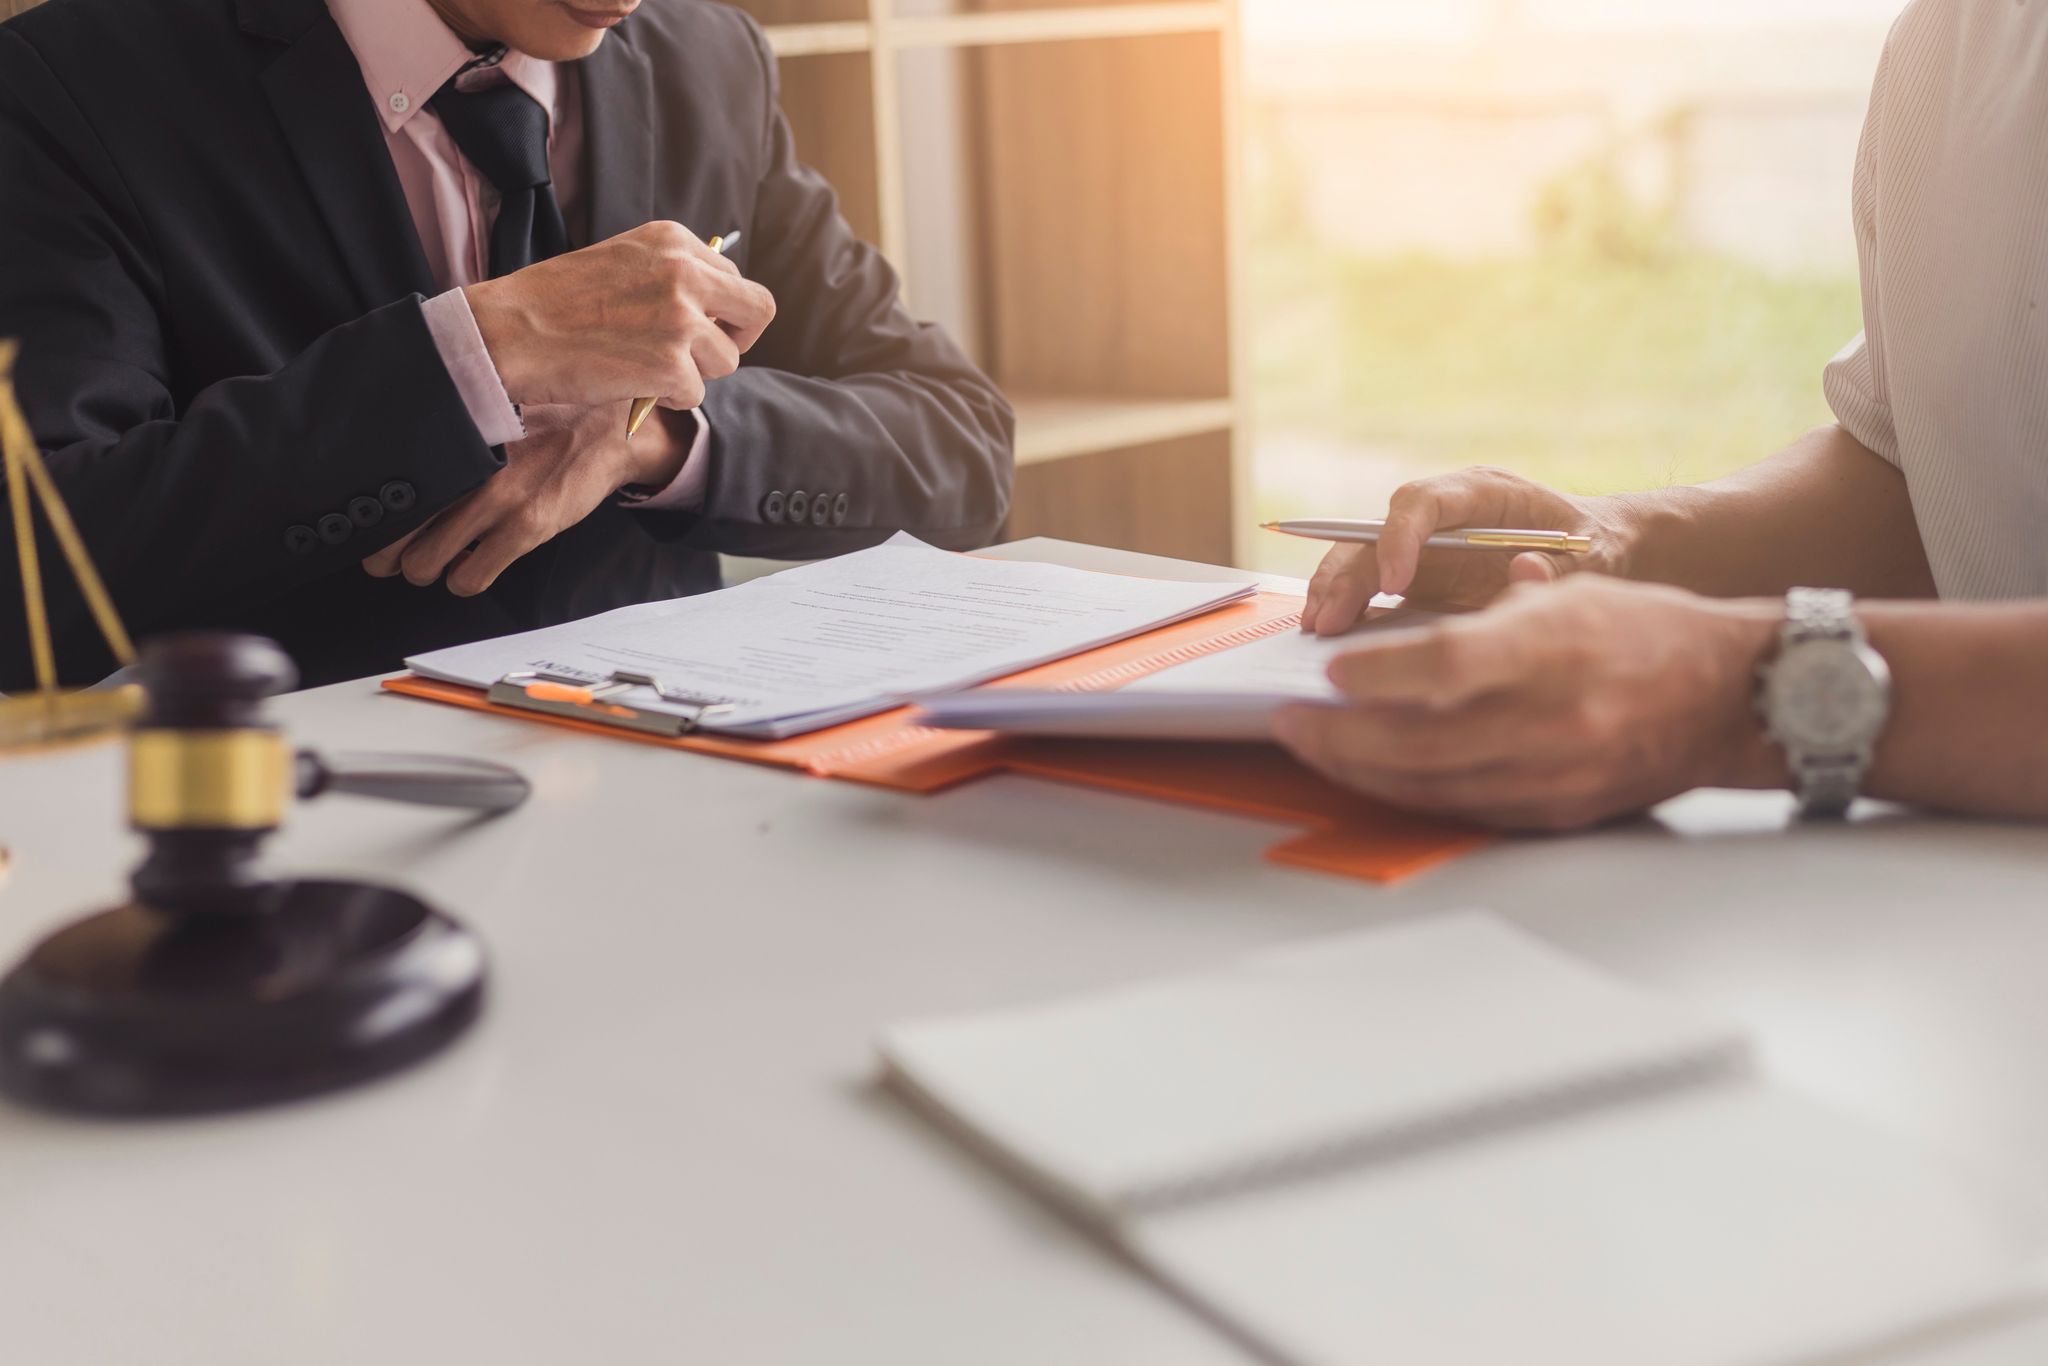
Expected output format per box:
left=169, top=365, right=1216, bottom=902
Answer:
left=1300, top=469, right=1634, bottom=635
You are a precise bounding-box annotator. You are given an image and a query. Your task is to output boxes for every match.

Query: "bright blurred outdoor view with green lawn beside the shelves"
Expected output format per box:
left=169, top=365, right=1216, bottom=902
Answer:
left=1243, top=0, right=1901, bottom=573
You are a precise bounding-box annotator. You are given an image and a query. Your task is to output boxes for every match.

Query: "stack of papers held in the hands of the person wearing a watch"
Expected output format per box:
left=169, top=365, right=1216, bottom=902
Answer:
left=918, top=608, right=1442, bottom=739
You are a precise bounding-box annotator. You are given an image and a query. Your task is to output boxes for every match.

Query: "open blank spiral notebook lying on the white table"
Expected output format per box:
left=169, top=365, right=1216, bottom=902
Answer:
left=881, top=913, right=2040, bottom=1366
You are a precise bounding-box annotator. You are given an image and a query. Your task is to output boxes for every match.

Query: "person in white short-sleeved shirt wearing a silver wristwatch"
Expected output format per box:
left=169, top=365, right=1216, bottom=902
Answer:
left=1278, top=0, right=2048, bottom=827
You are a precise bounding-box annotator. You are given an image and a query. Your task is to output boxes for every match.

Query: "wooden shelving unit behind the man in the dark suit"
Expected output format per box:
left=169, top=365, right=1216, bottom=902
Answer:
left=741, top=0, right=1249, bottom=561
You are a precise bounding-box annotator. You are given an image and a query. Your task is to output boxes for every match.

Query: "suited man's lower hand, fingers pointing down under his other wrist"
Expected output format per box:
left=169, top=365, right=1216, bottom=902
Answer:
left=362, top=401, right=694, bottom=598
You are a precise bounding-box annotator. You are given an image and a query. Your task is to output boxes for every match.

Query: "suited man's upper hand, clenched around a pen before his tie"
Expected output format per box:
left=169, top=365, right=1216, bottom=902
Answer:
left=463, top=221, right=774, bottom=413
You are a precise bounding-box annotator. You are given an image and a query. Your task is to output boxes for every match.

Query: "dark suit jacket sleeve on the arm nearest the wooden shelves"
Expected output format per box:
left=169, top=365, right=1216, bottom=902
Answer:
left=682, top=23, right=1014, bottom=559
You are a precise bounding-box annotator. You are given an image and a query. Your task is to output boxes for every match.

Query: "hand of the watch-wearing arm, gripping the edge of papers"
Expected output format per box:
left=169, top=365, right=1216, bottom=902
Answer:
left=1274, top=575, right=1784, bottom=829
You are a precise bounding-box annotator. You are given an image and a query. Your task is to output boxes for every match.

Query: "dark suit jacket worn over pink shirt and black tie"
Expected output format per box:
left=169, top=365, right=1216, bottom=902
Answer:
left=0, top=0, right=1012, bottom=688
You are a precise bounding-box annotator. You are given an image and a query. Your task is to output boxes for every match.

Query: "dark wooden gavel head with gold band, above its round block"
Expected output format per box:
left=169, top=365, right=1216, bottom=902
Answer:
left=129, top=633, right=299, bottom=915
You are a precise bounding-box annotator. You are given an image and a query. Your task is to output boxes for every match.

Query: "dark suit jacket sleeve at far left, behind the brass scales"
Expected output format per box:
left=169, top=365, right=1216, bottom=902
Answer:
left=0, top=29, right=500, bottom=688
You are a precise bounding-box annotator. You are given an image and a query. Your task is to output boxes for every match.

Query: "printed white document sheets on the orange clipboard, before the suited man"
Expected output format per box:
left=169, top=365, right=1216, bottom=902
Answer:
left=406, top=537, right=1251, bottom=737
